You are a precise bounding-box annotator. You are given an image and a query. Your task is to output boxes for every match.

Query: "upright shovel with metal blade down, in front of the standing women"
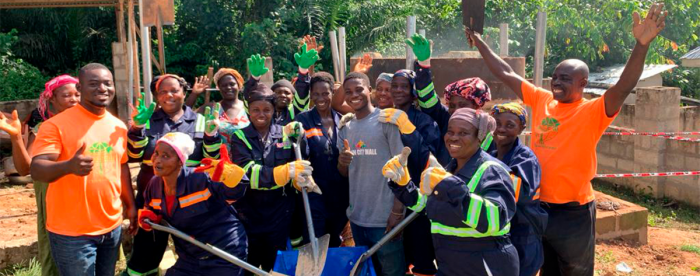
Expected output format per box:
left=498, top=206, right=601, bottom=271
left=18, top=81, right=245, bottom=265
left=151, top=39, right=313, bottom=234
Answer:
left=292, top=134, right=330, bottom=276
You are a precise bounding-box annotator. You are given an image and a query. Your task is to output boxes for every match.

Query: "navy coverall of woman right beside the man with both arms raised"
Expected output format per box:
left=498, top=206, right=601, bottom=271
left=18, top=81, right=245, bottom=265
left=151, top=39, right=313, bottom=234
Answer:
left=490, top=138, right=547, bottom=276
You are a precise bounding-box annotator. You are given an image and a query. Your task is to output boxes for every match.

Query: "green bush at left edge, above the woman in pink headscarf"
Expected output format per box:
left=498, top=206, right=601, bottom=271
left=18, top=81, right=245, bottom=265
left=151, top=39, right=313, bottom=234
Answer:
left=0, top=30, right=46, bottom=101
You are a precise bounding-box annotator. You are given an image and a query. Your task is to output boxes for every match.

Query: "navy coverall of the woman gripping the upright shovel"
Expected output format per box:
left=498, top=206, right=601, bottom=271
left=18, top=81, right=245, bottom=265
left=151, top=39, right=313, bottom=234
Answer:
left=231, top=124, right=298, bottom=271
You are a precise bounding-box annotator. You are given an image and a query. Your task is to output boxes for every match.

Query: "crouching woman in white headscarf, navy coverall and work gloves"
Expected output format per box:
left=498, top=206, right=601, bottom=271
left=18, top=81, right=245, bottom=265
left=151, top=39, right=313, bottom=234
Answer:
left=139, top=132, right=247, bottom=276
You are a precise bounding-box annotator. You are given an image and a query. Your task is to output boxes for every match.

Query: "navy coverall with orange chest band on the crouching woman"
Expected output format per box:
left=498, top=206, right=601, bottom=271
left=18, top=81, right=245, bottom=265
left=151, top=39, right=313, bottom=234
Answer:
left=142, top=167, right=248, bottom=276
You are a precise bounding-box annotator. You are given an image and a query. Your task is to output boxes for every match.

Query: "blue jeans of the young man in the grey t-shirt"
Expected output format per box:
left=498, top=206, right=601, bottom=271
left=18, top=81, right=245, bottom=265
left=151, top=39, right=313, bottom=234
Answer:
left=350, top=222, right=406, bottom=276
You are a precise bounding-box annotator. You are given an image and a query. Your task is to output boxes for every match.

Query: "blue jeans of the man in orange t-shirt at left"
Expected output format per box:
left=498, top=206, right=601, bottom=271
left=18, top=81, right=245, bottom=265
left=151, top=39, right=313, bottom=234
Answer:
left=49, top=226, right=122, bottom=276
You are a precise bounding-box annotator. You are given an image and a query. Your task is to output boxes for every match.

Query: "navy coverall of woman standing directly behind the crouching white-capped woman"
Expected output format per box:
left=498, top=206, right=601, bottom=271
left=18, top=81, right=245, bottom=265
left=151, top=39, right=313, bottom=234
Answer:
left=127, top=105, right=222, bottom=275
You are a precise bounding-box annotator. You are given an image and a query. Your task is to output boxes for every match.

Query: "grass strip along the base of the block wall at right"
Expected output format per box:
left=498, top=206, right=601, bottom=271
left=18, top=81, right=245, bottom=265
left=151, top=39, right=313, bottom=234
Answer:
left=593, top=180, right=700, bottom=231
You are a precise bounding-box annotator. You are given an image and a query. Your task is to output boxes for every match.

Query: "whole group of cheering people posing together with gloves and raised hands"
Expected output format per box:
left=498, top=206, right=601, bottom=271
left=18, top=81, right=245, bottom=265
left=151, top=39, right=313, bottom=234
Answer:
left=0, top=4, right=666, bottom=276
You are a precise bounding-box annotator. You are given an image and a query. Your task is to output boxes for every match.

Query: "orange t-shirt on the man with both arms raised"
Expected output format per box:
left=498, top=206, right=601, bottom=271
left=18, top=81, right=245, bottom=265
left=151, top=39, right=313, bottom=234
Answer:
left=520, top=81, right=617, bottom=204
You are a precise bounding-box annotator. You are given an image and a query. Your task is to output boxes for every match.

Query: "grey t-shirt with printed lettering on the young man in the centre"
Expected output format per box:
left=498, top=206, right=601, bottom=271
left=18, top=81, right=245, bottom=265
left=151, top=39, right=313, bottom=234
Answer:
left=338, top=108, right=403, bottom=227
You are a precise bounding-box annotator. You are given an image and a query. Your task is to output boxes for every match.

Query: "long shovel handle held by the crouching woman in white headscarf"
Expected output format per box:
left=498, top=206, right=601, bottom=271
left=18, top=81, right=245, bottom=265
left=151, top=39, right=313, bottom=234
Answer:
left=144, top=219, right=286, bottom=276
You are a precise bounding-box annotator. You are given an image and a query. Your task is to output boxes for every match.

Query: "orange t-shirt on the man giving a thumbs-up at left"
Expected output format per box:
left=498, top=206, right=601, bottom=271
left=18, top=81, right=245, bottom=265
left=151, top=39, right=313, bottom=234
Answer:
left=32, top=105, right=128, bottom=236
